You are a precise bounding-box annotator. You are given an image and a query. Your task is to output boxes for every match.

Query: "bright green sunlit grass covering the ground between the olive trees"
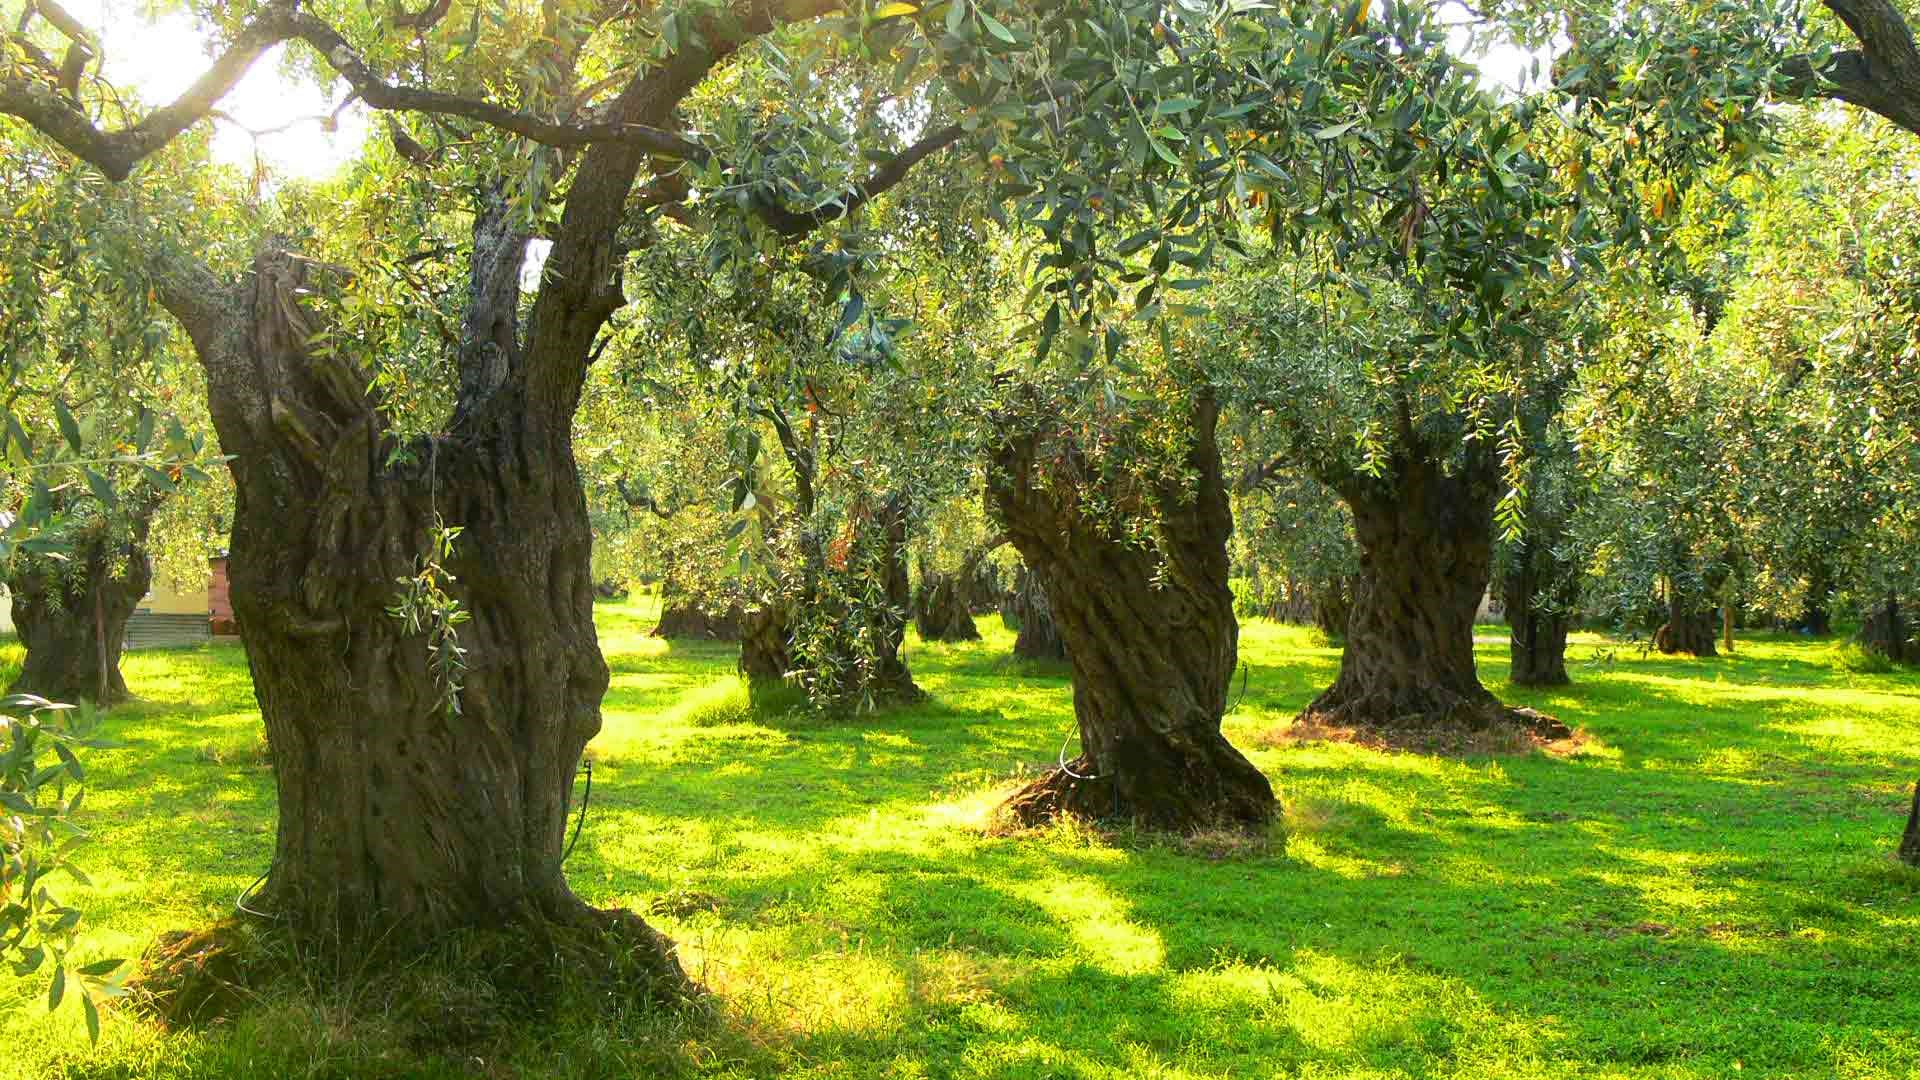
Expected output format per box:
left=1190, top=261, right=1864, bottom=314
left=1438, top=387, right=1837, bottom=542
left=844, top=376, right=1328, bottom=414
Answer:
left=0, top=601, right=1920, bottom=1078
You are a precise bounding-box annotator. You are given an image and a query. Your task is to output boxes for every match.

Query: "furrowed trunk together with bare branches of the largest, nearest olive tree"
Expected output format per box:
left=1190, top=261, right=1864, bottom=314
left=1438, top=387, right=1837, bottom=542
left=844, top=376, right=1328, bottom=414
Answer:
left=0, top=4, right=964, bottom=990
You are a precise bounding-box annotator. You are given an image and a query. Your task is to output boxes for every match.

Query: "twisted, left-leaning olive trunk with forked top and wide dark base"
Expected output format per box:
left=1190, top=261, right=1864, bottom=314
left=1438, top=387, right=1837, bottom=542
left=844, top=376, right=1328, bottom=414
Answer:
left=989, top=390, right=1275, bottom=832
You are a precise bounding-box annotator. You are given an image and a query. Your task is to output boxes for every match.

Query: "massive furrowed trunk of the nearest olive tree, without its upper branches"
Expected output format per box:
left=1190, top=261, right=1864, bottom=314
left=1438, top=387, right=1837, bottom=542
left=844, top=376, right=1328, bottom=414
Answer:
left=153, top=245, right=687, bottom=992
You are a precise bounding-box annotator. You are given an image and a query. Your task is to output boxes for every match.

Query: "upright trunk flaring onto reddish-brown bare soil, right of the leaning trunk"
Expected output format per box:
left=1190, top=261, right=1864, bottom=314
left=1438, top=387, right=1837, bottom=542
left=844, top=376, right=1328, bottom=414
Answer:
left=1302, top=445, right=1565, bottom=734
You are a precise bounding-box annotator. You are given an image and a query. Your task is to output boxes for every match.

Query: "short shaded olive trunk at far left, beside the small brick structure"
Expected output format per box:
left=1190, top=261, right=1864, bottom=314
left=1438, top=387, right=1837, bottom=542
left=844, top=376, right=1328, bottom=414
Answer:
left=8, top=509, right=154, bottom=705
